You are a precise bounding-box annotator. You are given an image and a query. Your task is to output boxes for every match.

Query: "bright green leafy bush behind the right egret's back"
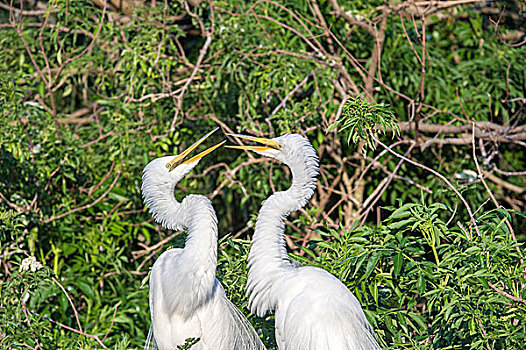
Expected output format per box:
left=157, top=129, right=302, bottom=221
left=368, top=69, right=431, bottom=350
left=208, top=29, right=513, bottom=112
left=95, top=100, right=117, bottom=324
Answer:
left=310, top=203, right=526, bottom=349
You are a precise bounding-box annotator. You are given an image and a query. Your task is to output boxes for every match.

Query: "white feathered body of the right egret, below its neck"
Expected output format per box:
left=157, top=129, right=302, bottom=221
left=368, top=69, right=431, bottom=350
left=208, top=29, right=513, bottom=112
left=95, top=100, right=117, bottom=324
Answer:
left=276, top=266, right=378, bottom=350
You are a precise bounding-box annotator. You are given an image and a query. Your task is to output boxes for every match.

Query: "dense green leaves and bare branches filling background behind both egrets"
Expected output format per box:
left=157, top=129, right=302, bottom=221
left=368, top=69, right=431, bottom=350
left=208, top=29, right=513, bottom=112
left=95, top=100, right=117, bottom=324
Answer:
left=0, top=0, right=526, bottom=349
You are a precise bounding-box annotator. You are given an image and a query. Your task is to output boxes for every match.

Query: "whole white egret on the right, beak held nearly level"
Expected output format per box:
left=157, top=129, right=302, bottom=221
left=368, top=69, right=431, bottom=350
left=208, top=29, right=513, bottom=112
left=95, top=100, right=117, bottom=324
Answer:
left=227, top=134, right=380, bottom=350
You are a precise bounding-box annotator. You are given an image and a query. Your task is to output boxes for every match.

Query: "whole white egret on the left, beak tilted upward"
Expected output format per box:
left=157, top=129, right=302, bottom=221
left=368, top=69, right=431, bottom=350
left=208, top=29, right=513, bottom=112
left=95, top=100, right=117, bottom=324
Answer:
left=142, top=129, right=265, bottom=350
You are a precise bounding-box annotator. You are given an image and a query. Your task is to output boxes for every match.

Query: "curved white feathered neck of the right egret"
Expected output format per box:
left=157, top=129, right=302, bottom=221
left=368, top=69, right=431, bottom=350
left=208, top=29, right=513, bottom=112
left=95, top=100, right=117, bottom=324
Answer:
left=247, top=145, right=318, bottom=316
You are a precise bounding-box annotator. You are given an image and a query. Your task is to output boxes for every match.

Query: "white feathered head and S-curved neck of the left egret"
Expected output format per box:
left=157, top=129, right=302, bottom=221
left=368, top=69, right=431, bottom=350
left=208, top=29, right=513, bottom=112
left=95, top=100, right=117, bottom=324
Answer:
left=142, top=158, right=217, bottom=314
